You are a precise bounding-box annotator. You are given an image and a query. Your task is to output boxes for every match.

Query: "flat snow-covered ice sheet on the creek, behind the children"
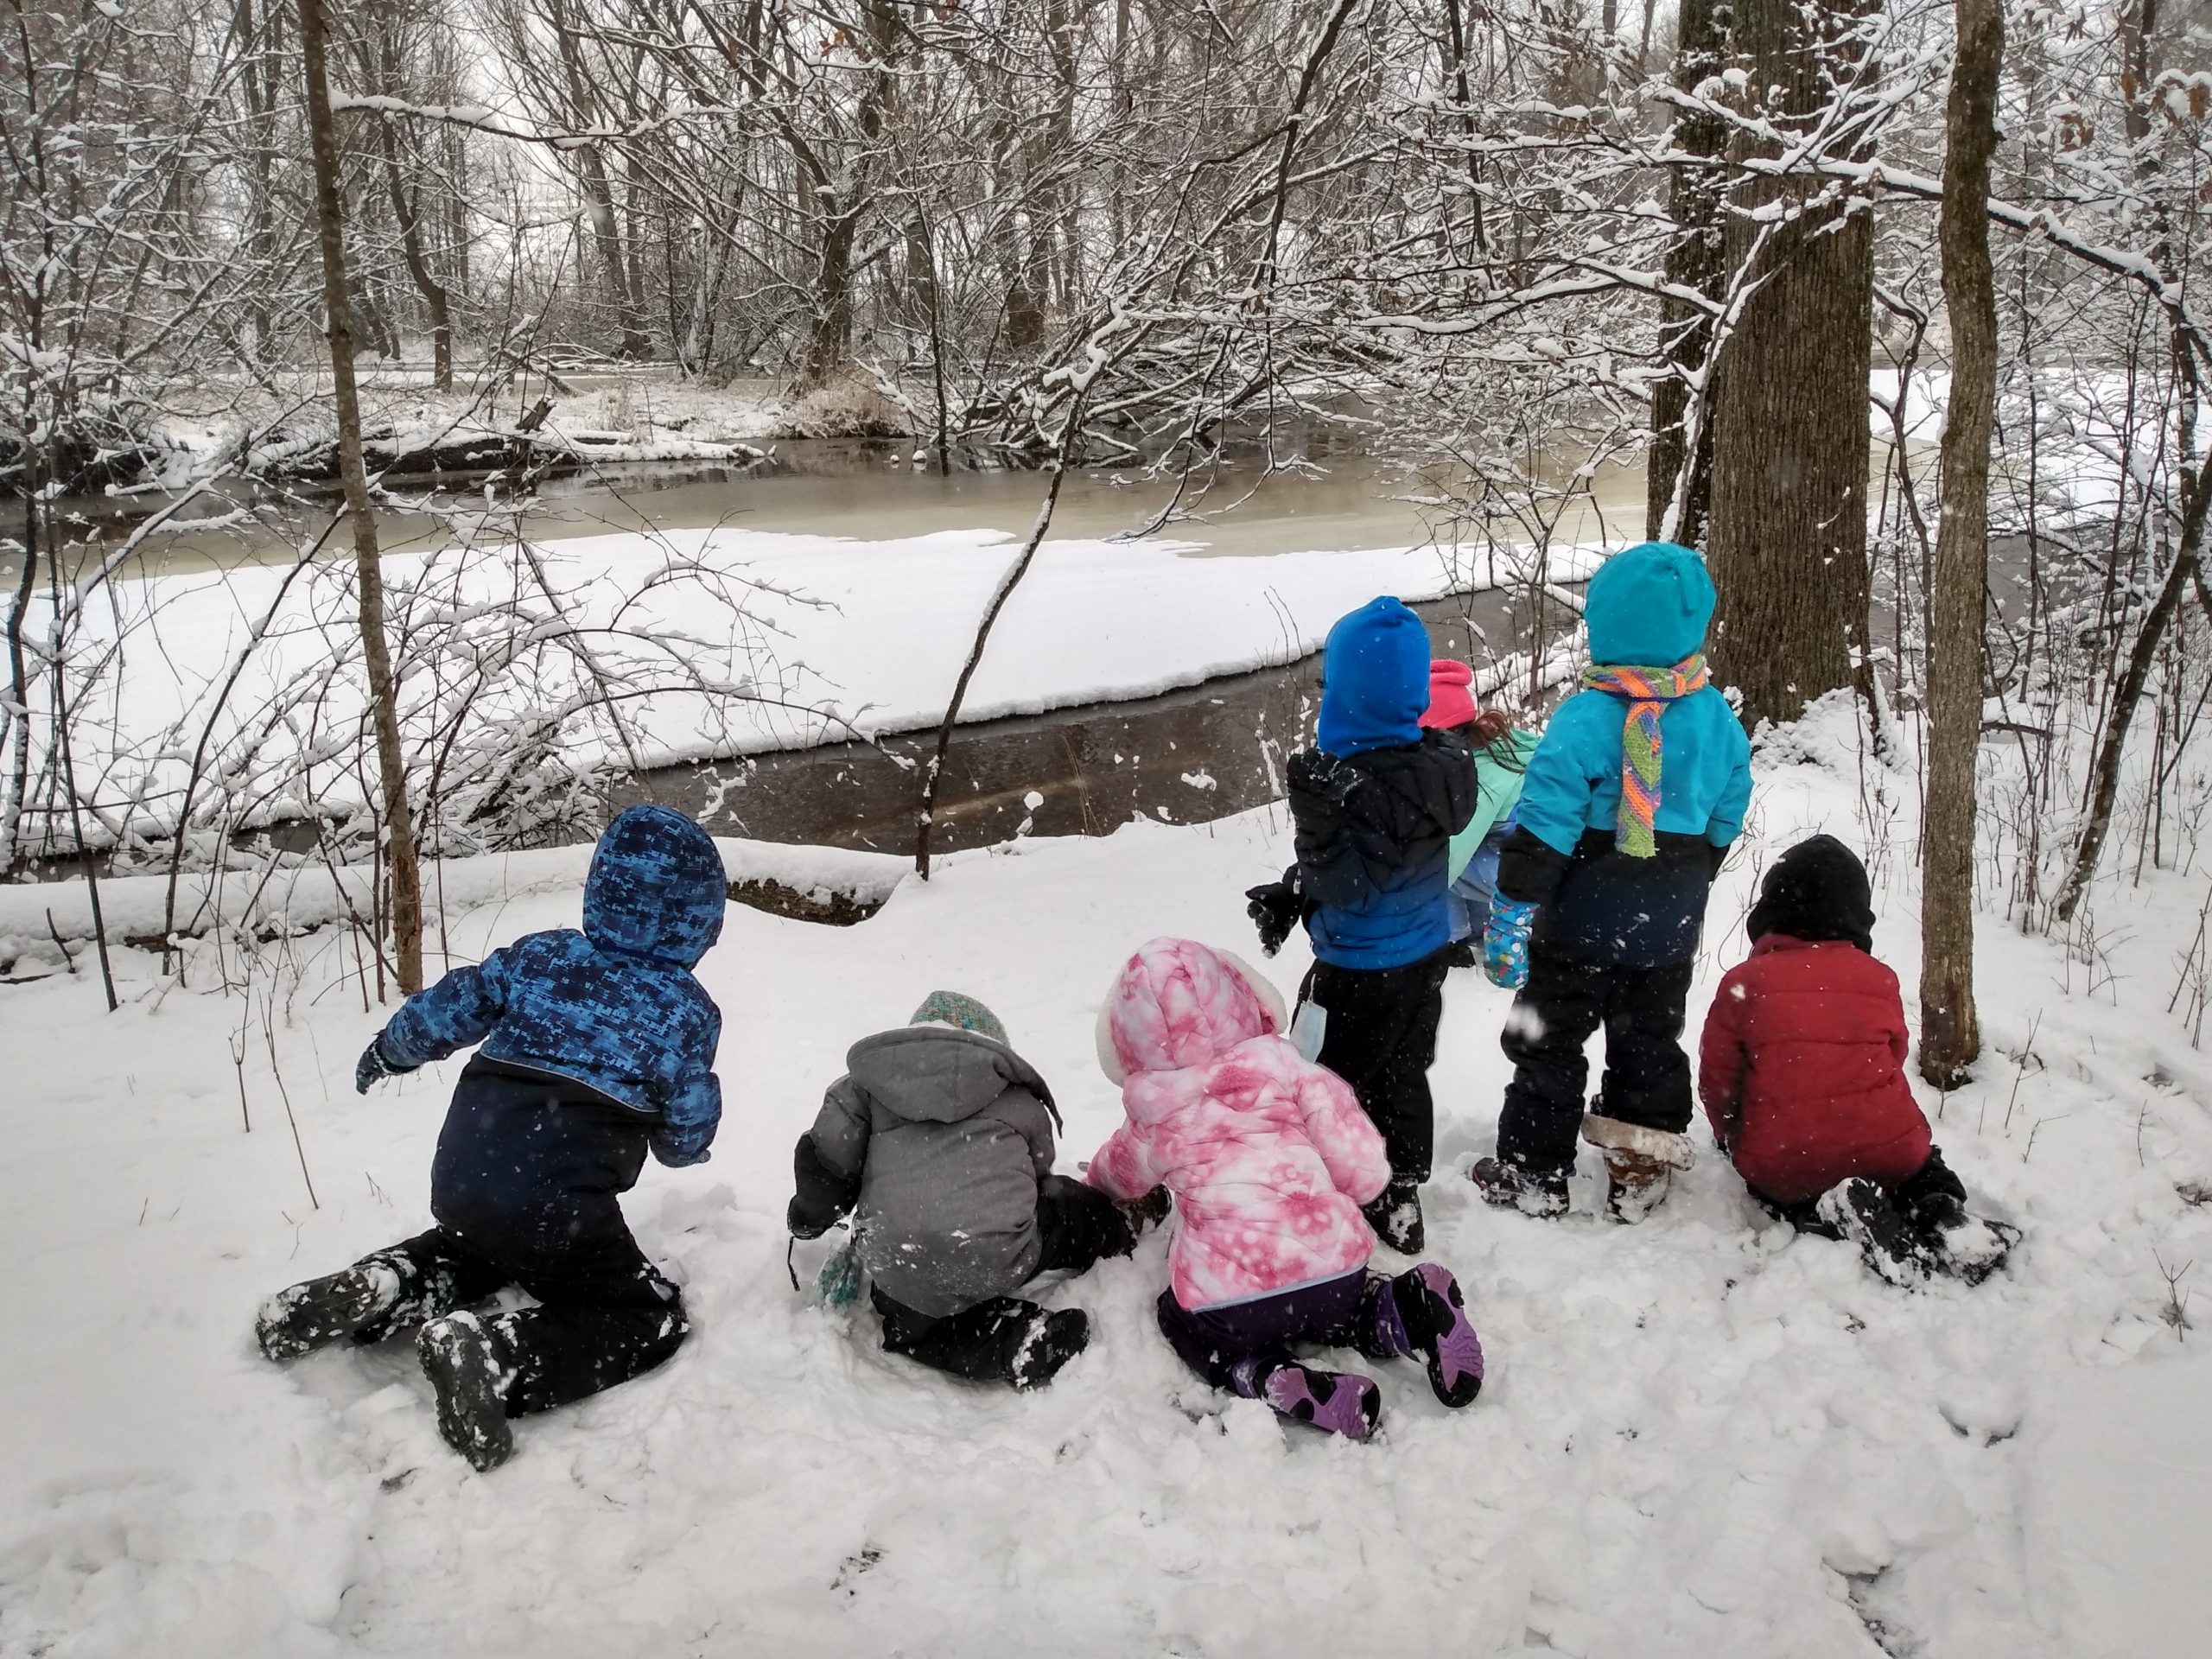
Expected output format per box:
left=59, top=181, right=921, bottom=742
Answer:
left=48, top=529, right=1595, bottom=834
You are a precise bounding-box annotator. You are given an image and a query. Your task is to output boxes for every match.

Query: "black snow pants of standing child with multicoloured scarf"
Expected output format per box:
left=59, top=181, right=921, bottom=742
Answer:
left=1497, top=940, right=1697, bottom=1174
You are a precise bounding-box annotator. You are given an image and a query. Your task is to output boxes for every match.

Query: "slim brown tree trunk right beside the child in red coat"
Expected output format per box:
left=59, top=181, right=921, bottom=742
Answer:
left=1920, top=0, right=2004, bottom=1089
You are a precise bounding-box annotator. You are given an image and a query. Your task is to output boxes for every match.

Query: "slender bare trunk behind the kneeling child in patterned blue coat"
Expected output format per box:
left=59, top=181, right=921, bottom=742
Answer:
left=302, top=0, right=423, bottom=995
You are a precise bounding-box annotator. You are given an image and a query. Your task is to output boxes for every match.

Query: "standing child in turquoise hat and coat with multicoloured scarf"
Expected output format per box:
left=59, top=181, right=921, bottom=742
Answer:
left=1473, top=542, right=1752, bottom=1221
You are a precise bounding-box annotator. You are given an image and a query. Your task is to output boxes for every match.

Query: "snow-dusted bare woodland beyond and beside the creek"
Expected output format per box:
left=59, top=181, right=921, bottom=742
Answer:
left=0, top=0, right=2212, bottom=1075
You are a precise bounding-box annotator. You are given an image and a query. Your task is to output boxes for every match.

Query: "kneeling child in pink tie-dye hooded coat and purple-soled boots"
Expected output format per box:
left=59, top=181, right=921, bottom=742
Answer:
left=1090, top=938, right=1482, bottom=1440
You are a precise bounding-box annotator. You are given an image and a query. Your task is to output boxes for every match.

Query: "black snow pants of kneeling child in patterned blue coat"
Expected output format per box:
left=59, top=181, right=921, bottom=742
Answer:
left=356, top=1214, right=690, bottom=1418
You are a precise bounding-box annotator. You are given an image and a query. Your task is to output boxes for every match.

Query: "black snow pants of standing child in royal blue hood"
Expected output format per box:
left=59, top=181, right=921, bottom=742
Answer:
left=1300, top=949, right=1451, bottom=1184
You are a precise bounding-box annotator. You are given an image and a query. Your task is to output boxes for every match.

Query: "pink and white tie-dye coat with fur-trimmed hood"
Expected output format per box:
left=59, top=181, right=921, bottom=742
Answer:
left=1090, top=938, right=1389, bottom=1307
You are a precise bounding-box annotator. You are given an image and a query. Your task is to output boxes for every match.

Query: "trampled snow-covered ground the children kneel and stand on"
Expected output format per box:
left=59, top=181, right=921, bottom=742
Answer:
left=0, top=716, right=2212, bottom=1659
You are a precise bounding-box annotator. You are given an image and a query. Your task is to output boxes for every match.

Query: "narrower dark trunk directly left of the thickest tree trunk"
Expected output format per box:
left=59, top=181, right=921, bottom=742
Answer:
left=1645, top=0, right=1727, bottom=546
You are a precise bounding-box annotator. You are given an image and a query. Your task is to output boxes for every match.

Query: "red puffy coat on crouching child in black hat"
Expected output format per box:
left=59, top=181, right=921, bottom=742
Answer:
left=1697, top=933, right=1929, bottom=1204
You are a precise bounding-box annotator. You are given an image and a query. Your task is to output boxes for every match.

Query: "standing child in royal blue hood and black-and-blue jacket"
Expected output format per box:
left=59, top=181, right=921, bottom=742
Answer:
left=1245, top=597, right=1476, bottom=1255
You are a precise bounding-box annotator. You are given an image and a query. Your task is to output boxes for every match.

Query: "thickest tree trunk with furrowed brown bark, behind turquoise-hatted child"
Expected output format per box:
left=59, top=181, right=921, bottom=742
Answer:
left=1707, top=0, right=1873, bottom=723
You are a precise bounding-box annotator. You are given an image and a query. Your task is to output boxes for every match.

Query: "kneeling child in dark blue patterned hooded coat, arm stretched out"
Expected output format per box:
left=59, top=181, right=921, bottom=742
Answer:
left=257, top=805, right=728, bottom=1469
